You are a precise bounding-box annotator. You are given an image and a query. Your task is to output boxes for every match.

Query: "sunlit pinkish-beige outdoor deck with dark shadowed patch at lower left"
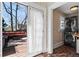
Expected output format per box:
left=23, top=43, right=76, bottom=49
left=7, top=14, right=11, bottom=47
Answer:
left=3, top=40, right=27, bottom=57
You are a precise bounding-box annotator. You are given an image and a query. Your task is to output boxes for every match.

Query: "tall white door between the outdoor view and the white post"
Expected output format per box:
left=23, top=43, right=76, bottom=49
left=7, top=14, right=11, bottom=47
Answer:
left=28, top=8, right=44, bottom=56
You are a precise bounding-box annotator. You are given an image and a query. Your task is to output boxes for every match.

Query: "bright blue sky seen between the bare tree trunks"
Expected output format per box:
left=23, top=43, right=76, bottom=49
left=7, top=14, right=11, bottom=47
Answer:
left=2, top=2, right=28, bottom=28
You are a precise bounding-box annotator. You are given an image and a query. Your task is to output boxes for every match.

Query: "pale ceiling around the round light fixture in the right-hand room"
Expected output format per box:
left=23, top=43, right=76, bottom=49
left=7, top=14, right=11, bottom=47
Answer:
left=57, top=2, right=79, bottom=14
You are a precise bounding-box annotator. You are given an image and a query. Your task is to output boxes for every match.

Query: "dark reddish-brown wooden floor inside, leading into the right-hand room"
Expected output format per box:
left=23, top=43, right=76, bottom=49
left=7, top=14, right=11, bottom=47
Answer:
left=35, top=45, right=79, bottom=57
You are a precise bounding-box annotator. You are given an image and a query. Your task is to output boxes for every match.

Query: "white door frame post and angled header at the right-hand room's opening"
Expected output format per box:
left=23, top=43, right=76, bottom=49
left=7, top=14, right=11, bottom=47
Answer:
left=47, top=2, right=68, bottom=54
